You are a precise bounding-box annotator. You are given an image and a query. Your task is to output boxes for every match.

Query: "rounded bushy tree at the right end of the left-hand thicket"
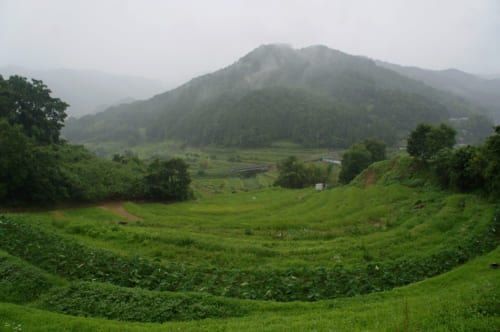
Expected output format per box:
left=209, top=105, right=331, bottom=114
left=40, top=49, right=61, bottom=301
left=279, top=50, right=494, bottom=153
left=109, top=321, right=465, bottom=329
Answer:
left=144, top=158, right=191, bottom=200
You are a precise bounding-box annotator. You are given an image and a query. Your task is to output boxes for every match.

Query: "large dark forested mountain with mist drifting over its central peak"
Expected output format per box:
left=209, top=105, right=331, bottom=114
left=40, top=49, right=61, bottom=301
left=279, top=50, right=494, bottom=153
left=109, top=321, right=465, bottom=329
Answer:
left=63, top=45, right=492, bottom=147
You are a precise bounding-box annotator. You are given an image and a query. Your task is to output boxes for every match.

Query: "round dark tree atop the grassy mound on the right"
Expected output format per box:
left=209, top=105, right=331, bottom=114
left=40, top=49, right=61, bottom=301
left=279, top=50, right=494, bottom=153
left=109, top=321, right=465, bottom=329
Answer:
left=406, top=123, right=456, bottom=161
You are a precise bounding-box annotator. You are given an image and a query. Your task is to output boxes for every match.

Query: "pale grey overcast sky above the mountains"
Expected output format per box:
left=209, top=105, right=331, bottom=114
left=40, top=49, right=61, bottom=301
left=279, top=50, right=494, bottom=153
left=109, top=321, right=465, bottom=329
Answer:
left=0, top=0, right=500, bottom=85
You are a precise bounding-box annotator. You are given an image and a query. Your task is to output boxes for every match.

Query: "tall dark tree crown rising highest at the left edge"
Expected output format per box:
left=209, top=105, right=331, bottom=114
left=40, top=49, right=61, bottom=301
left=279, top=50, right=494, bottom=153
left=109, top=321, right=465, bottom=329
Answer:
left=0, top=75, right=68, bottom=144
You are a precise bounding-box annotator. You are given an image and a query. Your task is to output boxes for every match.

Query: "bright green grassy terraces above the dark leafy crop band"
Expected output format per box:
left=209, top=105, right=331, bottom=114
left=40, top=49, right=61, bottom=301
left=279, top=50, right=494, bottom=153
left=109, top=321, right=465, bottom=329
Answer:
left=17, top=185, right=494, bottom=269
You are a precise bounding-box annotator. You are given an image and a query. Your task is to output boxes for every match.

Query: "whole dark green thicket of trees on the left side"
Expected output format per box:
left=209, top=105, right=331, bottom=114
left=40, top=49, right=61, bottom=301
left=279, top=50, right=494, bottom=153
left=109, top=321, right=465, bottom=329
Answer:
left=0, top=76, right=192, bottom=205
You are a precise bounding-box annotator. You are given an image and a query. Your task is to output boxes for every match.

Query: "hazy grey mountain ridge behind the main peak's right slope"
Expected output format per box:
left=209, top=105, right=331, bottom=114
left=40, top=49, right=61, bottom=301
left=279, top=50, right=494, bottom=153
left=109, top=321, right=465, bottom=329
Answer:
left=376, top=61, right=500, bottom=123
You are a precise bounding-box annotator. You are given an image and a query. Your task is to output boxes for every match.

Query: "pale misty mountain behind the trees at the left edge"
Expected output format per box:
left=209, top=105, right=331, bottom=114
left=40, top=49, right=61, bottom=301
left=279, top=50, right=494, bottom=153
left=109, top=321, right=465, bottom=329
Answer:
left=0, top=66, right=165, bottom=117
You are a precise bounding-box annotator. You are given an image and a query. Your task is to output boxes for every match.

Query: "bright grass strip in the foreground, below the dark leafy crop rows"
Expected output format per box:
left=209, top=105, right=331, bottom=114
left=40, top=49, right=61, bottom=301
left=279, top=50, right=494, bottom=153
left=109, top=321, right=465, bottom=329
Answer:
left=0, top=249, right=500, bottom=331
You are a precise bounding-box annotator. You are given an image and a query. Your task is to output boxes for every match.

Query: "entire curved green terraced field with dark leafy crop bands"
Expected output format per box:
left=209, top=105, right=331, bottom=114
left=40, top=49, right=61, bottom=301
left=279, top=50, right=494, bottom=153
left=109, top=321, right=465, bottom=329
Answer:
left=0, top=158, right=500, bottom=331
